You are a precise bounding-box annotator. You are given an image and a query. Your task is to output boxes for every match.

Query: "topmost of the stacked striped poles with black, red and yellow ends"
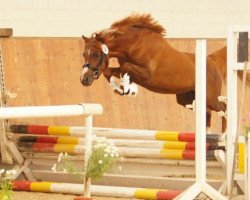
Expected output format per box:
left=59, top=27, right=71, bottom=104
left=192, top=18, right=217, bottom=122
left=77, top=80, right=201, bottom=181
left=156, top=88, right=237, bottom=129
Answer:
left=8, top=124, right=224, bottom=143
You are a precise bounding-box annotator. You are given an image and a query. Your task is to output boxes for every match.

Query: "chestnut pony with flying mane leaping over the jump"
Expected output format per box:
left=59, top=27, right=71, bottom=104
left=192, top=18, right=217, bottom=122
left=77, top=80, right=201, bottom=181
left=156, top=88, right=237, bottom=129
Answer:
left=80, top=15, right=226, bottom=131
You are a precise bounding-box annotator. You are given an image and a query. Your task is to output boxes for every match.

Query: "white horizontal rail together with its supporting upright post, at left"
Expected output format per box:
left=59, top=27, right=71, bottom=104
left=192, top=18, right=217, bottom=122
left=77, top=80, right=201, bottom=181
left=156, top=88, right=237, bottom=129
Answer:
left=0, top=104, right=103, bottom=197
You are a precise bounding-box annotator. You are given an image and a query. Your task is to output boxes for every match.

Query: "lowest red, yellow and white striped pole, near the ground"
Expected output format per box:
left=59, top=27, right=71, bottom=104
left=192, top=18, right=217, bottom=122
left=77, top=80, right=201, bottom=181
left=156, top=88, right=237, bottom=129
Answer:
left=12, top=180, right=181, bottom=200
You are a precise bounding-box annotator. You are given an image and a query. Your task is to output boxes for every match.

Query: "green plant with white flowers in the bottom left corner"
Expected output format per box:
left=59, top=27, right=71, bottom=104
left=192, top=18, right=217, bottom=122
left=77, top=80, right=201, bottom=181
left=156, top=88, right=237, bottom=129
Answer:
left=0, top=169, right=16, bottom=200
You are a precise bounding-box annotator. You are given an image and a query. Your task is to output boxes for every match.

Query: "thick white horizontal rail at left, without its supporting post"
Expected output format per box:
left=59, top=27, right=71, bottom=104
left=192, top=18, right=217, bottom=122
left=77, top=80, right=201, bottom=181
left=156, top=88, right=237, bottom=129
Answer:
left=0, top=104, right=103, bottom=119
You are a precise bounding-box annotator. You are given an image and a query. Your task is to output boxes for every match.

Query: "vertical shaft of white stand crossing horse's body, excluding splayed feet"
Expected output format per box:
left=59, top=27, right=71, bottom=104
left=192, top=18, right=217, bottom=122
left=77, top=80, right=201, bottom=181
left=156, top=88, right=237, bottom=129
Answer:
left=195, top=40, right=207, bottom=187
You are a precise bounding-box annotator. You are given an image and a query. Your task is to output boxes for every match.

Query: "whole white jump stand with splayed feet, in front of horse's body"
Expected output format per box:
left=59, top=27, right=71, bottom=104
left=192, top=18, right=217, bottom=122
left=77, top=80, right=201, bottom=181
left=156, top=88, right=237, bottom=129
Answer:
left=175, top=40, right=226, bottom=200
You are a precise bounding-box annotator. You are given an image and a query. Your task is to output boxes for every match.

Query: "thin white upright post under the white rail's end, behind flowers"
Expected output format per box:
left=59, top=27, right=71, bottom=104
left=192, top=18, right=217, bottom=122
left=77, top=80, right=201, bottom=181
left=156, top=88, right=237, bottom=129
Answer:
left=83, top=115, right=93, bottom=198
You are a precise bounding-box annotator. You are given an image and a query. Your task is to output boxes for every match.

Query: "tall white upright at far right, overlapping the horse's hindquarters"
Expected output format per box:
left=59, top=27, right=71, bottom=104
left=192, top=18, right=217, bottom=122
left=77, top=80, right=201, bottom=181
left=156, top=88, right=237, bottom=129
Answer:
left=227, top=28, right=238, bottom=194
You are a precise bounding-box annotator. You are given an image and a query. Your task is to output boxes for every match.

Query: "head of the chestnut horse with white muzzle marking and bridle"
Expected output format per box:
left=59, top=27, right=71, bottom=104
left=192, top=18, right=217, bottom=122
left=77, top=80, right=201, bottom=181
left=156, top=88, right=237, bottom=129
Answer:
left=80, top=34, right=109, bottom=86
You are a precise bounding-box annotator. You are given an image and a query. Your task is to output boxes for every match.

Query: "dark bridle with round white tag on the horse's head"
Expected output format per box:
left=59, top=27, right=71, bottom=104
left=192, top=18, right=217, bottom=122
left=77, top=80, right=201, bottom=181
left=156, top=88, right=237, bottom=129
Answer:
left=83, top=39, right=109, bottom=79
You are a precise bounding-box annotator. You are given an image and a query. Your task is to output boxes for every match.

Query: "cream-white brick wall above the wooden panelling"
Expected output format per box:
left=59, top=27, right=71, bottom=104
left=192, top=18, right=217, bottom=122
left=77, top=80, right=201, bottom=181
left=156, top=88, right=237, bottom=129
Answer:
left=0, top=0, right=250, bottom=38
